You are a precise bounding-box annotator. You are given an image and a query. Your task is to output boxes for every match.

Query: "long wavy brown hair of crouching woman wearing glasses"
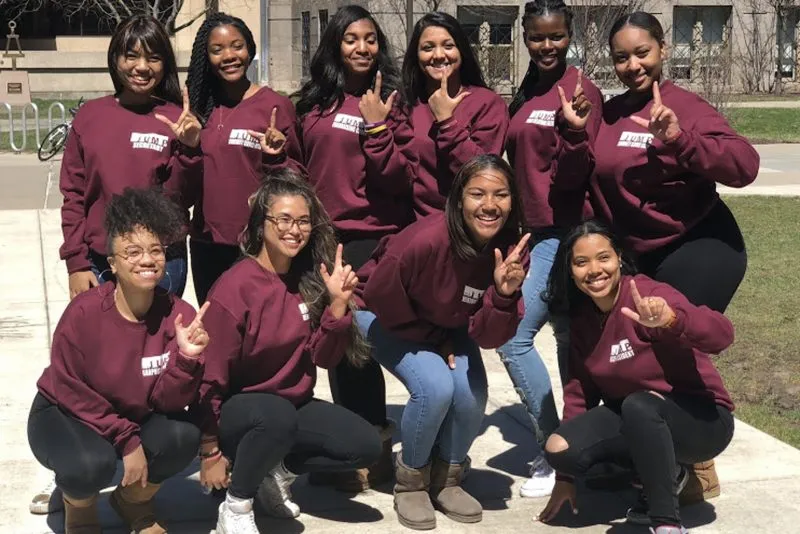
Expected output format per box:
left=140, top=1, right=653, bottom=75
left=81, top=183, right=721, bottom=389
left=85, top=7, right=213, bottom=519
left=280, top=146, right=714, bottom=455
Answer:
left=239, top=168, right=370, bottom=367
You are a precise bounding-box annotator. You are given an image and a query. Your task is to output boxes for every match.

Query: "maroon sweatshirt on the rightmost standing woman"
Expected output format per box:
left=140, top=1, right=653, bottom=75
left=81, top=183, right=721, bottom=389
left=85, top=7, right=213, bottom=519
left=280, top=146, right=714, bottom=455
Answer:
left=591, top=81, right=759, bottom=253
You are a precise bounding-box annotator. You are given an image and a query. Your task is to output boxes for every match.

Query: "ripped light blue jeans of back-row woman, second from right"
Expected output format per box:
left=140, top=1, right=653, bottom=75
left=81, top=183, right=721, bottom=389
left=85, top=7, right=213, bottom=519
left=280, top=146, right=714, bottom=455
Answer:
left=498, top=237, right=569, bottom=449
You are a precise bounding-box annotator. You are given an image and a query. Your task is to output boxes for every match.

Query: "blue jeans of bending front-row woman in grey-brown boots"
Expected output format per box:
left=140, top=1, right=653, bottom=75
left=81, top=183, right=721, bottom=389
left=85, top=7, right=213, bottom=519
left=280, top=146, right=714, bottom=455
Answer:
left=356, top=310, right=488, bottom=469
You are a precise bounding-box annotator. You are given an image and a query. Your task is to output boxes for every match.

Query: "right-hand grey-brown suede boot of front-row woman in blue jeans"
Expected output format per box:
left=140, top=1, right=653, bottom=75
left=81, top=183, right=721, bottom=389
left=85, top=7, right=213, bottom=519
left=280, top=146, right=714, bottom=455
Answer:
left=431, top=458, right=483, bottom=523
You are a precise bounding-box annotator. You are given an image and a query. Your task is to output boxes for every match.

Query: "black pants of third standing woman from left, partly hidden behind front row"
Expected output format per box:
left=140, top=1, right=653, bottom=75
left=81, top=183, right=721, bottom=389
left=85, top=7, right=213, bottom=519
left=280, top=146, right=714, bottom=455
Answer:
left=328, top=239, right=386, bottom=426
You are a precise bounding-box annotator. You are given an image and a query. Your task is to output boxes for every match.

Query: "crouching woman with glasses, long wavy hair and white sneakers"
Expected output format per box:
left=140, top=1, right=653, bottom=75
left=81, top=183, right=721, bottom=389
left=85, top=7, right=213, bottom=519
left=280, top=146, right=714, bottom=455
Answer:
left=198, top=169, right=380, bottom=534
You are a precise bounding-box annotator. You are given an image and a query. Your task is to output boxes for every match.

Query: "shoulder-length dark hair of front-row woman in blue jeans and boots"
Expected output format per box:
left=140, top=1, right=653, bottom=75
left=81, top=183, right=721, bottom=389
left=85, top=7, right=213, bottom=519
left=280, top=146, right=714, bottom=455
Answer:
left=444, top=154, right=522, bottom=261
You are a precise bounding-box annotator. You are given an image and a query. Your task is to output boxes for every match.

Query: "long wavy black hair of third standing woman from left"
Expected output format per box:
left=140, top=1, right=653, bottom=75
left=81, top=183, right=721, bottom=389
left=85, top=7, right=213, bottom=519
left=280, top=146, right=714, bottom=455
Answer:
left=294, top=5, right=400, bottom=117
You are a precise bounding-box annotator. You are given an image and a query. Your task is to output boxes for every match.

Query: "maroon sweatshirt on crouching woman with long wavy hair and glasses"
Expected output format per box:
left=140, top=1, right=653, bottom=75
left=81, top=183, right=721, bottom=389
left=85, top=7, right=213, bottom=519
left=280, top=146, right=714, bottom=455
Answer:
left=199, top=257, right=352, bottom=435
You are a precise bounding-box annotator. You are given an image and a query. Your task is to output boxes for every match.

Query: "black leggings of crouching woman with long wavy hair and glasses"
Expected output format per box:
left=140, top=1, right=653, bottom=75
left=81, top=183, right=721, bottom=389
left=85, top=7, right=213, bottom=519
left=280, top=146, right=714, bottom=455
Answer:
left=219, top=393, right=381, bottom=499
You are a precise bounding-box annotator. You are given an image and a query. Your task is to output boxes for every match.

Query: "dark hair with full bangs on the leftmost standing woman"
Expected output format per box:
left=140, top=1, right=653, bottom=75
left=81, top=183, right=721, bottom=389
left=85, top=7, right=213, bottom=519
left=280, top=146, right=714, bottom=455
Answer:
left=108, top=15, right=183, bottom=105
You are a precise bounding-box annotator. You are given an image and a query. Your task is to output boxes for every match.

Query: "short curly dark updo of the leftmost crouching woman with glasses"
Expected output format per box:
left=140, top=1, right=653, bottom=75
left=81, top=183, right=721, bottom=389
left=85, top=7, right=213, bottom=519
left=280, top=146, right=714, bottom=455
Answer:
left=104, top=187, right=189, bottom=254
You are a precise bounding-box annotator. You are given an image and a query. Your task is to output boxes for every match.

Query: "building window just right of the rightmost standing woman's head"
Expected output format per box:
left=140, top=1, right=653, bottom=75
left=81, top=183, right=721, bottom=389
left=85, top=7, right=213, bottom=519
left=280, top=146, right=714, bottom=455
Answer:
left=670, top=6, right=731, bottom=81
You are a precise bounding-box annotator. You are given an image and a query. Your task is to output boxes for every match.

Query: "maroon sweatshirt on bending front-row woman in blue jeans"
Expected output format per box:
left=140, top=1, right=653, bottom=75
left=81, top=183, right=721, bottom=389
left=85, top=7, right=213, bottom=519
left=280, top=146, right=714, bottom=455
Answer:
left=358, top=213, right=524, bottom=348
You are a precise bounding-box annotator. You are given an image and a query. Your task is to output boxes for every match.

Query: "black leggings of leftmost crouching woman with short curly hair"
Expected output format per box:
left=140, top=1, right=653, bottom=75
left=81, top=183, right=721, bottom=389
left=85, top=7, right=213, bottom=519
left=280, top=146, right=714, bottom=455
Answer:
left=28, top=393, right=200, bottom=499
